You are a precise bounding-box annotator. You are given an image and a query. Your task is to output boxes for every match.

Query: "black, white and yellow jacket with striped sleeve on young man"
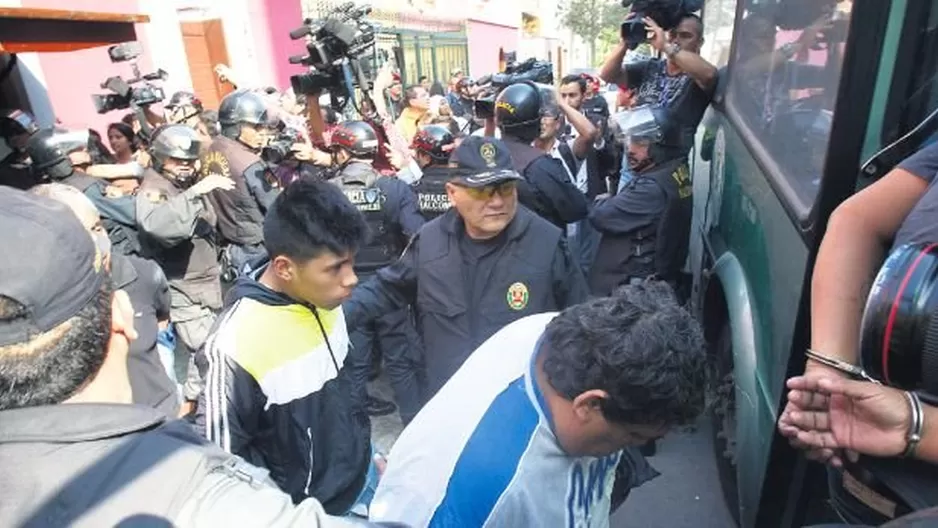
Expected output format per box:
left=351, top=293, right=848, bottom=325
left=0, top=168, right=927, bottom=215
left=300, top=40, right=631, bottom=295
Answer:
left=196, top=270, right=371, bottom=514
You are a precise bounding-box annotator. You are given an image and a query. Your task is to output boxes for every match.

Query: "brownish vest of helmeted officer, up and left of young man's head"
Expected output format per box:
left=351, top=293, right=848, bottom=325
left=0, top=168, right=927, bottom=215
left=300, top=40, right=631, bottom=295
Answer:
left=201, top=136, right=264, bottom=246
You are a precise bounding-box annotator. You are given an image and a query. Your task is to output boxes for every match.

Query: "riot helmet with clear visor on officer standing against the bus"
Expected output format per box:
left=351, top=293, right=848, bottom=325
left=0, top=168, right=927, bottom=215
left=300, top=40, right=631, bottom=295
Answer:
left=613, top=106, right=683, bottom=172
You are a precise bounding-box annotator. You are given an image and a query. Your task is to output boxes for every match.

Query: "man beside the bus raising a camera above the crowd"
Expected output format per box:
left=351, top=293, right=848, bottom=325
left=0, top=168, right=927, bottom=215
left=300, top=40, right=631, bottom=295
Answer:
left=600, top=14, right=717, bottom=155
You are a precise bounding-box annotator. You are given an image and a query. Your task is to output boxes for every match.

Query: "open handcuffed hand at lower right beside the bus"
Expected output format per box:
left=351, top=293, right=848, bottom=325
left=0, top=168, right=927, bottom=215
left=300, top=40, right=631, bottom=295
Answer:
left=779, top=376, right=912, bottom=466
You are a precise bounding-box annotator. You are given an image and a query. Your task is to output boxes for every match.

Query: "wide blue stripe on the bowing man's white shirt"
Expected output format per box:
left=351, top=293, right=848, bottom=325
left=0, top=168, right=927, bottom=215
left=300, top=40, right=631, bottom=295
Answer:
left=429, top=377, right=540, bottom=527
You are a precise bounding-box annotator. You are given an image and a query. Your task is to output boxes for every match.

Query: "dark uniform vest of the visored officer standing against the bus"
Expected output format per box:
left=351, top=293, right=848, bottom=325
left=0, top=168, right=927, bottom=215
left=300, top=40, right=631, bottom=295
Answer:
left=589, top=159, right=693, bottom=295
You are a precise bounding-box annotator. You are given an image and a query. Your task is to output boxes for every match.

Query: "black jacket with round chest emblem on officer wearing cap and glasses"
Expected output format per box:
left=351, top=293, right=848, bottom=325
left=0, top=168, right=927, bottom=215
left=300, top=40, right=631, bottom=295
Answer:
left=343, top=207, right=589, bottom=393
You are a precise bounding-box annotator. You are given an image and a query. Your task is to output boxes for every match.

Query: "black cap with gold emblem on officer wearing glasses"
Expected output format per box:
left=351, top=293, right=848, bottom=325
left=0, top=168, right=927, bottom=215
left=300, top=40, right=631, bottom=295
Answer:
left=450, top=136, right=523, bottom=187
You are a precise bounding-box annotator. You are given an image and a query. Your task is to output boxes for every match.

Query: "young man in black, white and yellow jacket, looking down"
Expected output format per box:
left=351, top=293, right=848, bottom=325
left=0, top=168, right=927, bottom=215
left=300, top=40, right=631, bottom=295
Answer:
left=198, top=179, right=376, bottom=514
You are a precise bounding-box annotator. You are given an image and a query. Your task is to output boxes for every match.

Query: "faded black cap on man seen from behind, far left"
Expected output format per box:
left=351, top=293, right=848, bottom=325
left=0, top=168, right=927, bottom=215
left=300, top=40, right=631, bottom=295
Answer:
left=0, top=187, right=105, bottom=346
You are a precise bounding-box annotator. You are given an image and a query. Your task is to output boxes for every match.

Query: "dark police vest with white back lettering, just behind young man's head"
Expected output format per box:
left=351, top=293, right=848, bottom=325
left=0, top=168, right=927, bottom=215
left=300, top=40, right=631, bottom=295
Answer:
left=333, top=162, right=404, bottom=273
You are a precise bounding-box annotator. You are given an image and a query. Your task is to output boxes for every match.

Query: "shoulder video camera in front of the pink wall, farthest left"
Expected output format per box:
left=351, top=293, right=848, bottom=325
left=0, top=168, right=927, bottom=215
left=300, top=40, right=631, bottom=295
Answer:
left=91, top=42, right=168, bottom=114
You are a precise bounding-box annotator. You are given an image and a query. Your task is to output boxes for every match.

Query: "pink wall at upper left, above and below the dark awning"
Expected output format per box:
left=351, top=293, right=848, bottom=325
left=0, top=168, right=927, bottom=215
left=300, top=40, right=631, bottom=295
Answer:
left=22, top=0, right=153, bottom=135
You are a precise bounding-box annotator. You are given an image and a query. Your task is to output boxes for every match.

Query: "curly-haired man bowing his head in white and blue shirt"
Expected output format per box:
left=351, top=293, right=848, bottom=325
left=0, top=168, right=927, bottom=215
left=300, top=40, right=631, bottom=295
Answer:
left=371, top=283, right=707, bottom=528
